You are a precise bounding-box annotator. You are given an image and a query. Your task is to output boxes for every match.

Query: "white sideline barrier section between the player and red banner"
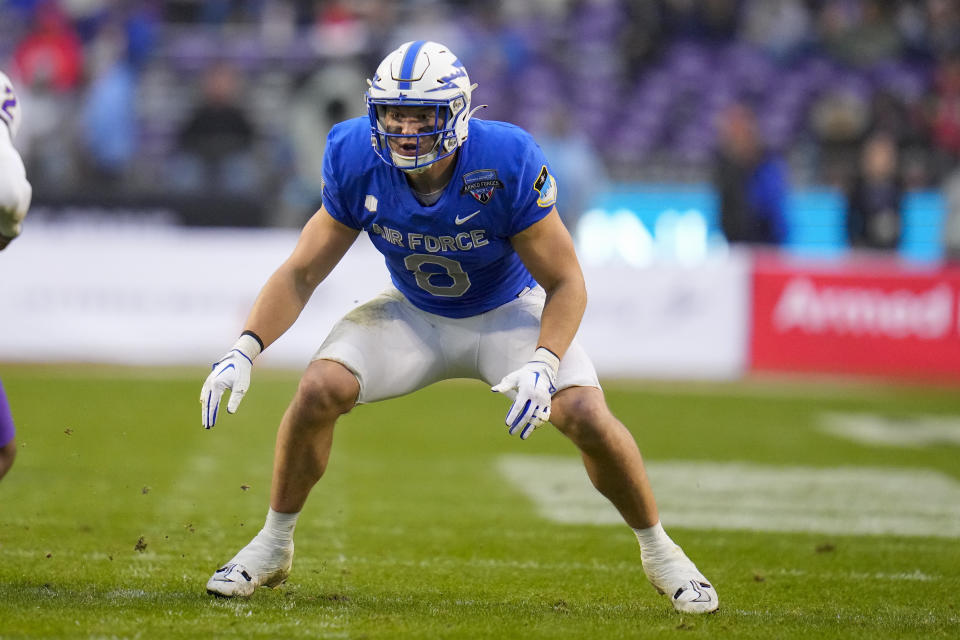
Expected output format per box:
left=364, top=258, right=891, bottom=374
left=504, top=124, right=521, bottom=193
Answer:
left=577, top=253, right=750, bottom=379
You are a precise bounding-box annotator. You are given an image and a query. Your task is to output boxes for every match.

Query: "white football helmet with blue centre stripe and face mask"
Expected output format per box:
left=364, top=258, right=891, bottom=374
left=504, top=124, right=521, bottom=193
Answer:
left=366, top=40, right=480, bottom=172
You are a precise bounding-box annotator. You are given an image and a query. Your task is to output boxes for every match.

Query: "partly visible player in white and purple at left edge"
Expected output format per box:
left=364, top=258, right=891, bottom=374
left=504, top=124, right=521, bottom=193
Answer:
left=0, top=72, right=33, bottom=478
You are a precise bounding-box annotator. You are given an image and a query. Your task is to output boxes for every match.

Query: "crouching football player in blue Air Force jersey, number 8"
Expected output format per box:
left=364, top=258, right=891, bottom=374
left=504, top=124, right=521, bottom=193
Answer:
left=200, top=41, right=718, bottom=613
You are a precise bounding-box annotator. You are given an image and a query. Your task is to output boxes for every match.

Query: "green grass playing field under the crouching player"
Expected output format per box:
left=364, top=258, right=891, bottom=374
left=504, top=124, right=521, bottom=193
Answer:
left=0, top=365, right=960, bottom=639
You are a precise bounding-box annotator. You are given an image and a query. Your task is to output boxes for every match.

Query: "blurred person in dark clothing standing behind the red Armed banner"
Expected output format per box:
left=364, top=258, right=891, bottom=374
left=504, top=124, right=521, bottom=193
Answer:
left=846, top=131, right=903, bottom=249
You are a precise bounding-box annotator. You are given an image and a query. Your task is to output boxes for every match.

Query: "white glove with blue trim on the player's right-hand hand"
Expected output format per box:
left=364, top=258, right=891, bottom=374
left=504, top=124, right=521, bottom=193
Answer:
left=490, top=347, right=560, bottom=440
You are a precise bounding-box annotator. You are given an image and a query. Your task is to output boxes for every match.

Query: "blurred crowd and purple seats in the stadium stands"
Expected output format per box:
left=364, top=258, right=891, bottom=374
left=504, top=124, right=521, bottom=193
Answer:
left=0, top=0, right=960, bottom=235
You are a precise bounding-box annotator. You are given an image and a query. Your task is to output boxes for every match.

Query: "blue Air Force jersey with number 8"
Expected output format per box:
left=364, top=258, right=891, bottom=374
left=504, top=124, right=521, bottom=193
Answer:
left=323, top=117, right=556, bottom=318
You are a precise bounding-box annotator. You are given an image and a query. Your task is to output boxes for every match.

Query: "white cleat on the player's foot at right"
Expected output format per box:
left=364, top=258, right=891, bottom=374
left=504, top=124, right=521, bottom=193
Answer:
left=640, top=545, right=720, bottom=613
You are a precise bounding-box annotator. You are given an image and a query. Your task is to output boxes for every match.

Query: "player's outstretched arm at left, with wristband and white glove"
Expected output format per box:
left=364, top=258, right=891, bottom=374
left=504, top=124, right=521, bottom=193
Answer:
left=200, top=207, right=360, bottom=429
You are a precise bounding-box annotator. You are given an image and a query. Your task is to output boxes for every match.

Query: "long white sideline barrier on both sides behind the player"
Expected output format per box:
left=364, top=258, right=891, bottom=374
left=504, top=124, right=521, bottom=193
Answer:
left=0, top=225, right=749, bottom=378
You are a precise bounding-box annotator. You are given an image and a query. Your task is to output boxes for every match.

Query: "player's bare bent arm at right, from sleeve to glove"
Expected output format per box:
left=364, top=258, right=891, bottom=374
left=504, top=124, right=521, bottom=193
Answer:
left=510, top=207, right=587, bottom=359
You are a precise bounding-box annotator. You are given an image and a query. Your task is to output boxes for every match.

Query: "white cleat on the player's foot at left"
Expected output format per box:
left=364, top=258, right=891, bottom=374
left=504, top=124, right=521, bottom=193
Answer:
left=207, top=533, right=293, bottom=598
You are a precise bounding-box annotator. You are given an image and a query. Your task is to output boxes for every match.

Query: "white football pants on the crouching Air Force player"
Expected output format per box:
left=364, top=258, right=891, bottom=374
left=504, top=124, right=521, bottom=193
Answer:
left=313, top=287, right=600, bottom=404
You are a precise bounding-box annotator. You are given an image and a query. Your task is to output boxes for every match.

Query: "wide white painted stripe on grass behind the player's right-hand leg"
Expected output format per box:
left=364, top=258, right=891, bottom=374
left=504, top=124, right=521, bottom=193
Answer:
left=498, top=455, right=960, bottom=538
